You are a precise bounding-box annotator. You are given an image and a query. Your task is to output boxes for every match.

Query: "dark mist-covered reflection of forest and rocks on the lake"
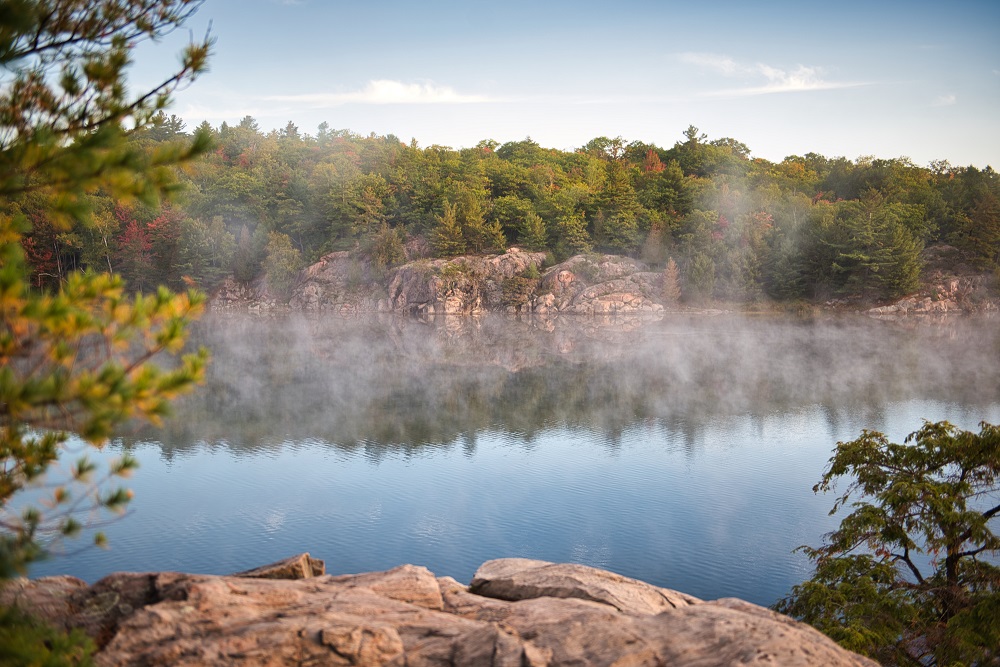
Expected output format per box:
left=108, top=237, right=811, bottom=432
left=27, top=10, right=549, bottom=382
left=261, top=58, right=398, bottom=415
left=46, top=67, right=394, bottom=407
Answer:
left=127, top=314, right=1000, bottom=460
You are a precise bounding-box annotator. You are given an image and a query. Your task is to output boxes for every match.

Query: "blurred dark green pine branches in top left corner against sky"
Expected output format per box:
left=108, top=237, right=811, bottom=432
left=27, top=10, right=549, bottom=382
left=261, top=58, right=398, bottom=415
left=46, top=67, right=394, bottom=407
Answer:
left=0, top=0, right=210, bottom=223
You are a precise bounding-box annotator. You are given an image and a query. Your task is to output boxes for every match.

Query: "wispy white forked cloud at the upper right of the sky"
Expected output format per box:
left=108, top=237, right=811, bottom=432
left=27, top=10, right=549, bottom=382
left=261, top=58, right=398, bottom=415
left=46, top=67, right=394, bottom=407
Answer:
left=679, top=52, right=867, bottom=97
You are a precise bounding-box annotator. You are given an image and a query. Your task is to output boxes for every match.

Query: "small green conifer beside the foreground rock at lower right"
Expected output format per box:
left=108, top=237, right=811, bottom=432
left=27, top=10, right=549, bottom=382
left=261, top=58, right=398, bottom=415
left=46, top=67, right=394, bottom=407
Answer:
left=776, top=422, right=1000, bottom=665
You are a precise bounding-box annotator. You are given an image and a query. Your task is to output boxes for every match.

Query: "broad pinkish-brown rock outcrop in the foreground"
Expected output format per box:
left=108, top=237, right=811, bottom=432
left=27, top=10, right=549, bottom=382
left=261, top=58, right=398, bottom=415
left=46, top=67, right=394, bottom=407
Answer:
left=7, top=555, right=876, bottom=667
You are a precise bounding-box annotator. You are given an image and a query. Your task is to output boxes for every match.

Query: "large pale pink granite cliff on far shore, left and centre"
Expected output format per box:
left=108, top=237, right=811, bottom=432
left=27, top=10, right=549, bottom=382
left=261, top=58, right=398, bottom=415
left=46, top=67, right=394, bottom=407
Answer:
left=221, top=248, right=663, bottom=315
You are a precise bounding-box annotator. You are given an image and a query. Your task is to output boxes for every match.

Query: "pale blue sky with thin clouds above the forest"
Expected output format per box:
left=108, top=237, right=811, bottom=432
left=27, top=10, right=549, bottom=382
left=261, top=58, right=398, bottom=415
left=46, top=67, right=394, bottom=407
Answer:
left=132, top=0, right=1000, bottom=168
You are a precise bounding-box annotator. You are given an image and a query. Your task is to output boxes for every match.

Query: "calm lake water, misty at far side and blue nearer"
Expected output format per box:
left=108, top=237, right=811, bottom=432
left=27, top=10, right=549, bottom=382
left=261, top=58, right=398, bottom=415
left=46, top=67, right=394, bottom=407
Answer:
left=23, top=315, right=1000, bottom=604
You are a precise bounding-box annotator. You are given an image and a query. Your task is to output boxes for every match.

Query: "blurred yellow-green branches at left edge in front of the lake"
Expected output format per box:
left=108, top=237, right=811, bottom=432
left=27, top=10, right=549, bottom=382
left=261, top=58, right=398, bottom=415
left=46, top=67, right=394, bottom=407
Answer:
left=0, top=244, right=208, bottom=577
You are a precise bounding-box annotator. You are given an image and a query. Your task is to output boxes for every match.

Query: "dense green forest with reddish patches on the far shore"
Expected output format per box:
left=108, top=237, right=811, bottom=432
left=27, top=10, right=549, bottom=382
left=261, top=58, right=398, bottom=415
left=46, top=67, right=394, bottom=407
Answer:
left=9, top=112, right=1000, bottom=301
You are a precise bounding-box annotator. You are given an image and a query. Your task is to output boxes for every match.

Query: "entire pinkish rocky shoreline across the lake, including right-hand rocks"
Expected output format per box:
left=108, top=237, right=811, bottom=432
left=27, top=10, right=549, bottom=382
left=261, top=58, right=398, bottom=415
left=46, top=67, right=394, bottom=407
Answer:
left=211, top=247, right=1000, bottom=318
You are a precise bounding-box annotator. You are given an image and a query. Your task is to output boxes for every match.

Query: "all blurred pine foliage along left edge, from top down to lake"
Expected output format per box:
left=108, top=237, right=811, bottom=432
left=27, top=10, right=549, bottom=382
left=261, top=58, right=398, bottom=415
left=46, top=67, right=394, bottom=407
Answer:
left=0, top=0, right=210, bottom=579
